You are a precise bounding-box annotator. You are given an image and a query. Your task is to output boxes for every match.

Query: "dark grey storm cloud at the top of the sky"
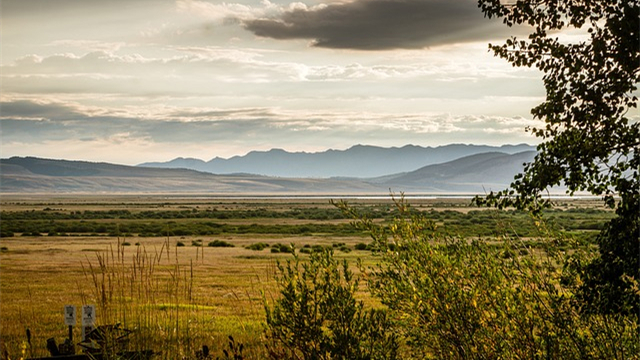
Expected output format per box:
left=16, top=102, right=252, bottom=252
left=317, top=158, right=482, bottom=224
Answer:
left=244, top=0, right=508, bottom=50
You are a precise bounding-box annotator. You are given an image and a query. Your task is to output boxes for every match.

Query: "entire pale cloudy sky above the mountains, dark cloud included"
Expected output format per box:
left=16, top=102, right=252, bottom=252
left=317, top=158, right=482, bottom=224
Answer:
left=0, top=0, right=604, bottom=165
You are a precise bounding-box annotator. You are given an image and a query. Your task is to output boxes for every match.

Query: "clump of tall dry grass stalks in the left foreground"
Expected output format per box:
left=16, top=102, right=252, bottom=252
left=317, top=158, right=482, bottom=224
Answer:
left=80, top=239, right=205, bottom=359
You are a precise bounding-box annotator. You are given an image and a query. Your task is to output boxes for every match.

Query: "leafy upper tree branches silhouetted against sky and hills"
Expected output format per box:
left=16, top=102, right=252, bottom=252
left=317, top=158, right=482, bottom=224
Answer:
left=472, top=0, right=640, bottom=211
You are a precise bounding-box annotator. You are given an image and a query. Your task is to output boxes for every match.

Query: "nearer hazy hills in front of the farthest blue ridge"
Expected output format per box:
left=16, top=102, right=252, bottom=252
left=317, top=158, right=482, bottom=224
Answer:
left=0, top=147, right=536, bottom=195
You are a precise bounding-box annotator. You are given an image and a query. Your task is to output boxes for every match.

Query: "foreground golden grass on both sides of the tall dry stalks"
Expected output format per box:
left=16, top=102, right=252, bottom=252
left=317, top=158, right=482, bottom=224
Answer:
left=0, top=237, right=278, bottom=356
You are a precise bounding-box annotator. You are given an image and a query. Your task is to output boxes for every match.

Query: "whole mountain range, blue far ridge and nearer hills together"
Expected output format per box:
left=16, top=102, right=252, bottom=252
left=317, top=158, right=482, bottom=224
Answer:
left=0, top=145, right=536, bottom=195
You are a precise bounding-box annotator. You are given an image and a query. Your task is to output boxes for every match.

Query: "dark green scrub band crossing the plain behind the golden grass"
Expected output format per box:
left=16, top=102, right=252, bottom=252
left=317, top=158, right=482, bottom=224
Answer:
left=1, top=205, right=613, bottom=240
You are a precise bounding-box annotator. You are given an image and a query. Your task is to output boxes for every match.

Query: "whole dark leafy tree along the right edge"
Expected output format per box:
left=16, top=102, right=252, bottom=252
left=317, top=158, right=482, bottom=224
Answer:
left=476, top=0, right=640, bottom=314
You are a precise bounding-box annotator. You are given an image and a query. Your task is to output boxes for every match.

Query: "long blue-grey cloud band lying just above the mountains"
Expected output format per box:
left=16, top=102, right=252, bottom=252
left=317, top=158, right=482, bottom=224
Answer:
left=0, top=99, right=531, bottom=153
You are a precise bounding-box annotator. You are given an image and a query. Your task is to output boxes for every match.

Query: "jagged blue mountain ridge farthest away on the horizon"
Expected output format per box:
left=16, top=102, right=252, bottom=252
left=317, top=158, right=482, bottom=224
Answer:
left=138, top=144, right=535, bottom=178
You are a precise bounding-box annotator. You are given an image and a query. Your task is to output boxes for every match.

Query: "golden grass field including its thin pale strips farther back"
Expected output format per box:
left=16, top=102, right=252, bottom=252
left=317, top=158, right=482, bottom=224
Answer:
left=0, top=196, right=608, bottom=359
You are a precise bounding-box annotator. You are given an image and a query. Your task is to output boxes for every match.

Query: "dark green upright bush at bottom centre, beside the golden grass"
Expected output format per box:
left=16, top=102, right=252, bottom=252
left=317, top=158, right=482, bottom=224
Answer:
left=265, top=250, right=398, bottom=359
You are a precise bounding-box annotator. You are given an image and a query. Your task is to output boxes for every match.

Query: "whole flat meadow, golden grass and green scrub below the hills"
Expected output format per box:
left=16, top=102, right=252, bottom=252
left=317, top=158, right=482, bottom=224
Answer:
left=0, top=196, right=612, bottom=359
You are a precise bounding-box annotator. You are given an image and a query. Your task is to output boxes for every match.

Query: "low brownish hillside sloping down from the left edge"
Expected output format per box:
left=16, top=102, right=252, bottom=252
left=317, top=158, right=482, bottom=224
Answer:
left=0, top=157, right=377, bottom=194
